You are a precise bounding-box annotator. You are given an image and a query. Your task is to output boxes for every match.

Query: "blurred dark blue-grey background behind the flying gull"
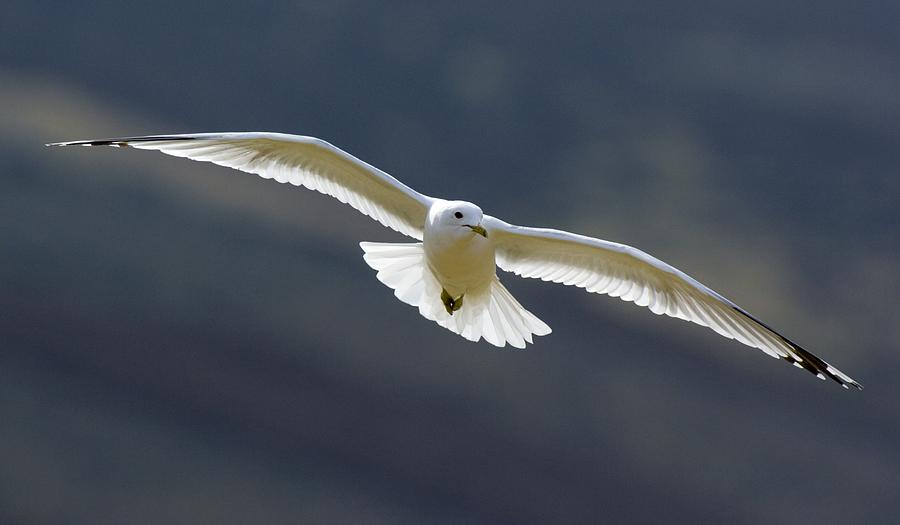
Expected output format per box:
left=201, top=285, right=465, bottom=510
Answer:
left=0, top=0, right=900, bottom=524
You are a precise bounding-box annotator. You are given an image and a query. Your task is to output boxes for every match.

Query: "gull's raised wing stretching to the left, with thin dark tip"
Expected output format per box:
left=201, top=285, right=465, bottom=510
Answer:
left=47, top=133, right=432, bottom=240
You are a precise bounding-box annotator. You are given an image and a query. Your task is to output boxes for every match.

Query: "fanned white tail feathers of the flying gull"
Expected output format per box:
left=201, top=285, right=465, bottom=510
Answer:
left=359, top=242, right=550, bottom=348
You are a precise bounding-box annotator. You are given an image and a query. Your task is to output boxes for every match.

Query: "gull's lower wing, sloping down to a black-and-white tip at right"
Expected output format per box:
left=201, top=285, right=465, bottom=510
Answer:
left=483, top=217, right=862, bottom=390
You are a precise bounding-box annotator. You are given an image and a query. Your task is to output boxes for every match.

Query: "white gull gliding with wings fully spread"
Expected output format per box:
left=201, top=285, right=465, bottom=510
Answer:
left=47, top=133, right=862, bottom=389
